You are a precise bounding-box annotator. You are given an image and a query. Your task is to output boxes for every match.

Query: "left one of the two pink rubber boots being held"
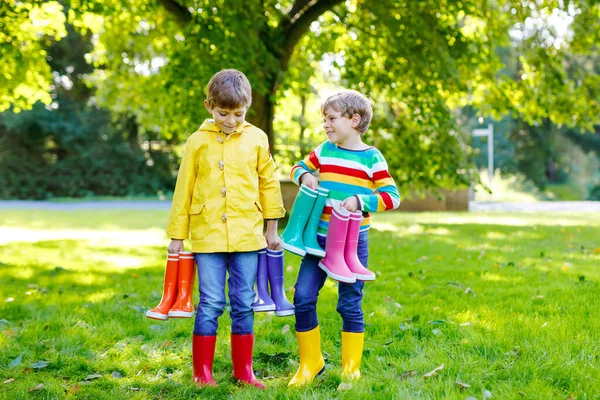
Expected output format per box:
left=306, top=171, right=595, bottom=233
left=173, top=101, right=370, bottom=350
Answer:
left=319, top=207, right=356, bottom=283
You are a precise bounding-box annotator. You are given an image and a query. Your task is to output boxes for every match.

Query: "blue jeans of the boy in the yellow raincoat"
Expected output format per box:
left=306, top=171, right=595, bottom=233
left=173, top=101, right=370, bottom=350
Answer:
left=194, top=251, right=258, bottom=336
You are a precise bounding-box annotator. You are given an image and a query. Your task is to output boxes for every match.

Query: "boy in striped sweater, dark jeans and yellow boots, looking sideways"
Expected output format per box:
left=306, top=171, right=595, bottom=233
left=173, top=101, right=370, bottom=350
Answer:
left=290, top=90, right=400, bottom=385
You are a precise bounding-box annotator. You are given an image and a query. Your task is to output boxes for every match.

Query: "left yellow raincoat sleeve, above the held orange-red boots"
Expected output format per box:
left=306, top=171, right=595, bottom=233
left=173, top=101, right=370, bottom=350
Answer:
left=167, top=139, right=198, bottom=240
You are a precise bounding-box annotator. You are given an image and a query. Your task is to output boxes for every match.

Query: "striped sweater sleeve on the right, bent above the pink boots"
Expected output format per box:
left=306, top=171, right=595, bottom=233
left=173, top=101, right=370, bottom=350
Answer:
left=357, top=153, right=400, bottom=212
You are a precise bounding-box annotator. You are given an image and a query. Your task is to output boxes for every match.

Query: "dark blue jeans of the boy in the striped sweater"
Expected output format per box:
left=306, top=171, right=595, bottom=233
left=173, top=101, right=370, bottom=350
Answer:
left=294, top=231, right=369, bottom=332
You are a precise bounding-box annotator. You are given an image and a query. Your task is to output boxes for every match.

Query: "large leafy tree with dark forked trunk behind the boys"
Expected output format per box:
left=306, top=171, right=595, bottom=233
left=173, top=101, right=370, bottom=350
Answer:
left=4, top=0, right=600, bottom=191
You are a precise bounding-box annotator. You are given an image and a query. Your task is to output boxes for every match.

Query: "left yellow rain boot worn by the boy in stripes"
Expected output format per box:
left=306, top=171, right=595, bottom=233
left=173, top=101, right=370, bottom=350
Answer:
left=288, top=325, right=325, bottom=386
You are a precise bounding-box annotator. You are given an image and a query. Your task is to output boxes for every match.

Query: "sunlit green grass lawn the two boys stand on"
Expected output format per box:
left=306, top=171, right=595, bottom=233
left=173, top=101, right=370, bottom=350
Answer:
left=0, top=210, right=600, bottom=399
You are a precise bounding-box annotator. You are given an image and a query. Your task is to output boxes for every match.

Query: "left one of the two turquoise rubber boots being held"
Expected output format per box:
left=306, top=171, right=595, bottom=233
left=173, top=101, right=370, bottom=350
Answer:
left=279, top=185, right=317, bottom=257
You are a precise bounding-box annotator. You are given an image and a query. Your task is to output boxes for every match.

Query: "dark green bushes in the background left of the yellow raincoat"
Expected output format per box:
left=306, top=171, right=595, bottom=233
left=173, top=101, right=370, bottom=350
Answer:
left=0, top=99, right=177, bottom=199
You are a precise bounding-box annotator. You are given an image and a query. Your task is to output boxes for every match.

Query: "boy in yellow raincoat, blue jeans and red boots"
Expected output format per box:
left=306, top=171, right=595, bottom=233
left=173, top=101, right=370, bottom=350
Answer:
left=167, top=69, right=285, bottom=388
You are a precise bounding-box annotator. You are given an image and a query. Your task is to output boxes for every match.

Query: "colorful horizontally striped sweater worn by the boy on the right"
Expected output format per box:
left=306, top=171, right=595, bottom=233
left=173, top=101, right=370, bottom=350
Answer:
left=290, top=141, right=400, bottom=236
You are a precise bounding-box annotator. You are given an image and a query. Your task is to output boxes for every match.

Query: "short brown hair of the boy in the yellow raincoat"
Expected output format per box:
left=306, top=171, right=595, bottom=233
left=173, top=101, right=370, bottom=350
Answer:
left=206, top=69, right=252, bottom=110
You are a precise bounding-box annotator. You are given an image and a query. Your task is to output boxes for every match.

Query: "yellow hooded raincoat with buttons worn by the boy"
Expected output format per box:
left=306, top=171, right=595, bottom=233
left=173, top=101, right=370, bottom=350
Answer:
left=167, top=119, right=285, bottom=253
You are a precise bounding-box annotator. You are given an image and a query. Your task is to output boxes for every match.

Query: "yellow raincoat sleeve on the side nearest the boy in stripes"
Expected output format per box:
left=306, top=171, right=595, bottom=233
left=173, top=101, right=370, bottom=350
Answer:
left=257, top=135, right=285, bottom=220
